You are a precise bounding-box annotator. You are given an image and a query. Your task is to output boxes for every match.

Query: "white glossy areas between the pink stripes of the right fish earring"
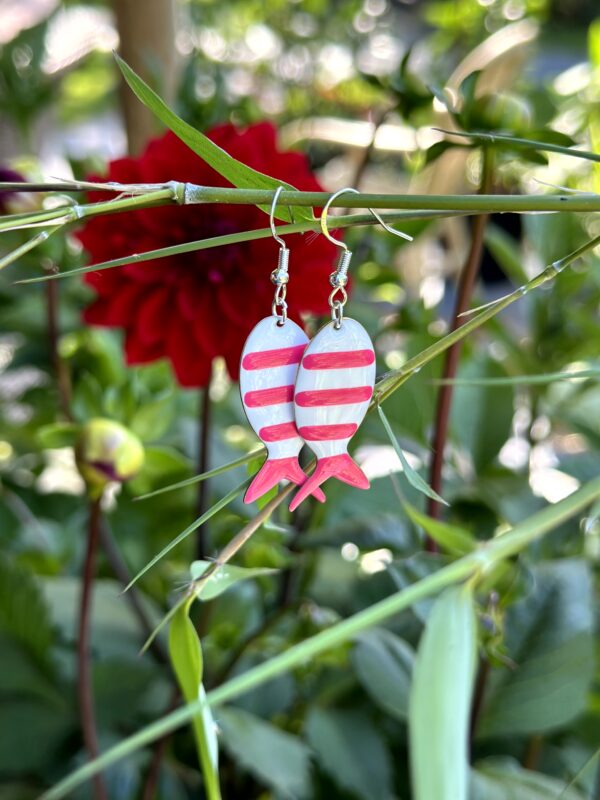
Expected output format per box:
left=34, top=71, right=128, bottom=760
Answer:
left=294, top=318, right=375, bottom=458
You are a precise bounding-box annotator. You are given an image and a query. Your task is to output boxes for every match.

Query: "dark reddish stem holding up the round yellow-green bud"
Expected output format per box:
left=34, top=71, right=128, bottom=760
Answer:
left=77, top=498, right=108, bottom=800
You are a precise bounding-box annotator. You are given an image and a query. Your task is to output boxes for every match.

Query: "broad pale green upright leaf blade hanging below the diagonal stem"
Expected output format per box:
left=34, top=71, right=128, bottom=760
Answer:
left=409, top=586, right=476, bottom=800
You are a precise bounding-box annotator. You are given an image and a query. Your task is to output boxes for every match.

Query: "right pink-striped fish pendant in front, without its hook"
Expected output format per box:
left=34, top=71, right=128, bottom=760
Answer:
left=290, top=318, right=375, bottom=511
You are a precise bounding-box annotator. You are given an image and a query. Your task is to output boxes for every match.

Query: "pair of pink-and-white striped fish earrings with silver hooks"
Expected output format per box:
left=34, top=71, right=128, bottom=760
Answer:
left=240, top=186, right=410, bottom=511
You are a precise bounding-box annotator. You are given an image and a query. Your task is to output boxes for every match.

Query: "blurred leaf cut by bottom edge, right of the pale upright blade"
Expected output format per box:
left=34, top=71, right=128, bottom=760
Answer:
left=470, top=758, right=586, bottom=800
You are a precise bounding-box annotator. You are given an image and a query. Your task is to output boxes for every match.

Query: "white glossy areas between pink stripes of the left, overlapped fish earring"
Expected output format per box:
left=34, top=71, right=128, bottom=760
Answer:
left=240, top=316, right=308, bottom=459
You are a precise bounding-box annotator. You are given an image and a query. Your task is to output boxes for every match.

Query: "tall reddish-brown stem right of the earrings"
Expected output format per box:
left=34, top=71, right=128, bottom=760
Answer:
left=425, top=148, right=493, bottom=532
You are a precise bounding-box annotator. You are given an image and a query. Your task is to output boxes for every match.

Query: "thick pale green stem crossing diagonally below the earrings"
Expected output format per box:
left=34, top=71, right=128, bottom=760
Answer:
left=40, top=478, right=600, bottom=800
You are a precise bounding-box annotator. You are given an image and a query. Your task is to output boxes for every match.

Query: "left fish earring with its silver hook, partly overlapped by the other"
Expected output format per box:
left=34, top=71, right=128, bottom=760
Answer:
left=240, top=186, right=325, bottom=503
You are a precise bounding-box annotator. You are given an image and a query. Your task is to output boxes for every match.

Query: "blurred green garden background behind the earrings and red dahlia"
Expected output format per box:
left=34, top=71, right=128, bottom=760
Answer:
left=0, top=0, right=600, bottom=800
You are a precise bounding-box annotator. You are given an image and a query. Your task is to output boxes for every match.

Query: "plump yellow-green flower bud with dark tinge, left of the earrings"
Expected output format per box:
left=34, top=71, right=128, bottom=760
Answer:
left=75, top=418, right=144, bottom=492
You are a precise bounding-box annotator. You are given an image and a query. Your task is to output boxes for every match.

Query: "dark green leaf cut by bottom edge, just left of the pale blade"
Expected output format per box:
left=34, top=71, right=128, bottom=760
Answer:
left=306, top=706, right=394, bottom=800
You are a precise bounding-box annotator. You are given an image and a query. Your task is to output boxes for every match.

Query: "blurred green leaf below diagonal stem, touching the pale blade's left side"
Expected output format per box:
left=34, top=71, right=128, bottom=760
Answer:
left=350, top=628, right=414, bottom=720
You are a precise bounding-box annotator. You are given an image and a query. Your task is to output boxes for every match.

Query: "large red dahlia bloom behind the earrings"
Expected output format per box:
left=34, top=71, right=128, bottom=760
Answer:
left=79, top=123, right=335, bottom=386
